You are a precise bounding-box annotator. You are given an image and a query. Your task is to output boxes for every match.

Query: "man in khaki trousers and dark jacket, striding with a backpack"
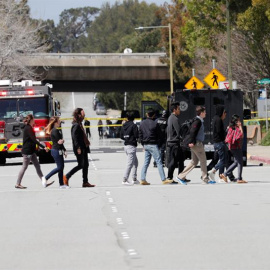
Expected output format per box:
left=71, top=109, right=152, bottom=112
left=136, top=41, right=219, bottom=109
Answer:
left=176, top=106, right=215, bottom=185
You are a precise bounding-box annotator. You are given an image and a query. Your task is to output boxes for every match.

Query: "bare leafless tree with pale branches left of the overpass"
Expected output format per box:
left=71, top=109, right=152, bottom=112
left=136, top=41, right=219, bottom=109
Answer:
left=0, top=0, right=48, bottom=81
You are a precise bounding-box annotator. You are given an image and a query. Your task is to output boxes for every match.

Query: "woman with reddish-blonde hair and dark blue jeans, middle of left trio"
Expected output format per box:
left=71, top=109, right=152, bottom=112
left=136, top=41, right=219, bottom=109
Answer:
left=45, top=116, right=69, bottom=189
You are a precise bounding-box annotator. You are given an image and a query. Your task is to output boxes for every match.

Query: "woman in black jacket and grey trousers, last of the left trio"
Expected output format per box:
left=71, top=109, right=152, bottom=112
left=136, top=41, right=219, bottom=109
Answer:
left=15, top=114, right=53, bottom=189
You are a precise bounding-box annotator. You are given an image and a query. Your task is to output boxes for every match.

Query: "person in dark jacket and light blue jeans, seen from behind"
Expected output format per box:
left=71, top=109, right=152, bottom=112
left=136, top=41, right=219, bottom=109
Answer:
left=139, top=108, right=173, bottom=185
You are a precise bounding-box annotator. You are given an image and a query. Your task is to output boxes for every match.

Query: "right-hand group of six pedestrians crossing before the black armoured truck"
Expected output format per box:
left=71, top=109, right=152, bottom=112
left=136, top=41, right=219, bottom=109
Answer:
left=121, top=102, right=247, bottom=185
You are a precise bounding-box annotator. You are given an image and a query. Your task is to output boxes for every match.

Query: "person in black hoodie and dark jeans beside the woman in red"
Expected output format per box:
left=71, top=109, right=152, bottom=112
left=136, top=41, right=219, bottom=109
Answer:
left=209, top=105, right=227, bottom=181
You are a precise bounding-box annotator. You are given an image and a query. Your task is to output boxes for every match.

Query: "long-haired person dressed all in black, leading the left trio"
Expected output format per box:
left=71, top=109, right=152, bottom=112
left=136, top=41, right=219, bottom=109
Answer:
left=63, top=108, right=95, bottom=187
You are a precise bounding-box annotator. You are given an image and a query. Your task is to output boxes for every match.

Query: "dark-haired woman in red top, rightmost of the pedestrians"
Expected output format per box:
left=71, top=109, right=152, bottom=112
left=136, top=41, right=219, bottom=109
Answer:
left=220, top=115, right=247, bottom=184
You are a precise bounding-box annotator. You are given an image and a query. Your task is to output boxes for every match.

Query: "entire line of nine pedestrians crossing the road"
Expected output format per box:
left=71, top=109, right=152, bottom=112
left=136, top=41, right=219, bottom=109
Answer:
left=15, top=102, right=247, bottom=189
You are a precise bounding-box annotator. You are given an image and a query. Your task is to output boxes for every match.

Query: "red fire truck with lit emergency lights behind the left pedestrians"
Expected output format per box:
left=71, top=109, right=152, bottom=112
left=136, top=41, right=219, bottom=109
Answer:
left=0, top=80, right=60, bottom=165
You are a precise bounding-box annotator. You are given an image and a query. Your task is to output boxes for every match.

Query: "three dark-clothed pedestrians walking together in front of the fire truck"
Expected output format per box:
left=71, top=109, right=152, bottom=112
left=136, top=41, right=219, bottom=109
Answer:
left=15, top=108, right=95, bottom=189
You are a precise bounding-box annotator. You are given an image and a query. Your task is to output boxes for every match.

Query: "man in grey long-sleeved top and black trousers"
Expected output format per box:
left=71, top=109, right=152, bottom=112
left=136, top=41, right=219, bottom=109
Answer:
left=166, top=102, right=187, bottom=184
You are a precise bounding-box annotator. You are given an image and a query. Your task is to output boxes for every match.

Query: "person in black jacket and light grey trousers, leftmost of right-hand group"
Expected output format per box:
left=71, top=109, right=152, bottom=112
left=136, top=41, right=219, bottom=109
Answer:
left=120, top=112, right=140, bottom=186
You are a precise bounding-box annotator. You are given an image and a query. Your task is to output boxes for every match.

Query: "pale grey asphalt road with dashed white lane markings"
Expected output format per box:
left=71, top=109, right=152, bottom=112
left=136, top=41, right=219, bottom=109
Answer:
left=0, top=92, right=270, bottom=270
